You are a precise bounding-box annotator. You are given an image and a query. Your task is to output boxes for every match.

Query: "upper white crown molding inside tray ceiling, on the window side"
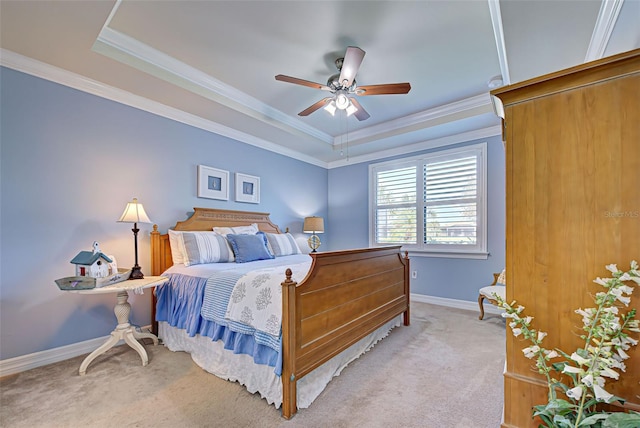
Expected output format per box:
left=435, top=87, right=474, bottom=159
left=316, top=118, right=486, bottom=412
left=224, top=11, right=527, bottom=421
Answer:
left=333, top=93, right=491, bottom=147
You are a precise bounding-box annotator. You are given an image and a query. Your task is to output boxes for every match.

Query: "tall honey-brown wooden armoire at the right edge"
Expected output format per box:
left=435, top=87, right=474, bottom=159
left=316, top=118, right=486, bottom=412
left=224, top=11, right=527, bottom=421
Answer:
left=491, top=49, right=640, bottom=427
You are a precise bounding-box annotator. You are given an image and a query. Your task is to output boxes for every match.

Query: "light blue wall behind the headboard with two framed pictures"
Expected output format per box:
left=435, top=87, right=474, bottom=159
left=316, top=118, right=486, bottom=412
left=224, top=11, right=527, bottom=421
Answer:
left=0, top=68, right=328, bottom=359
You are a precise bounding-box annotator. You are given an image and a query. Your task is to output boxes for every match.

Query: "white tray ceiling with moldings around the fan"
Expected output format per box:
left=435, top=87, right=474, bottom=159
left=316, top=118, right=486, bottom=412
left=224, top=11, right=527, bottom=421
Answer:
left=0, top=0, right=640, bottom=167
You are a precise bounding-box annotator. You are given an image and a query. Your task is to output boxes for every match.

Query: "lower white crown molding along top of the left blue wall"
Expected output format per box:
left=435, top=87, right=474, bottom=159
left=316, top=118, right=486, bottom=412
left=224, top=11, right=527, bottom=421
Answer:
left=0, top=49, right=327, bottom=168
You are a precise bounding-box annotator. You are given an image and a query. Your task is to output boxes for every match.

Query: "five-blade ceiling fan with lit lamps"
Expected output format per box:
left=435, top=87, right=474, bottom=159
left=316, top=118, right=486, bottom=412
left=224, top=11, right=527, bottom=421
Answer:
left=276, top=46, right=411, bottom=120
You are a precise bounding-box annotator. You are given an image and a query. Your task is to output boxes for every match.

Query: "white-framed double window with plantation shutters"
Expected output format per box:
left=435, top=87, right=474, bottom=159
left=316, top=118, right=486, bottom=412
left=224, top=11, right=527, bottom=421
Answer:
left=369, top=143, right=486, bottom=257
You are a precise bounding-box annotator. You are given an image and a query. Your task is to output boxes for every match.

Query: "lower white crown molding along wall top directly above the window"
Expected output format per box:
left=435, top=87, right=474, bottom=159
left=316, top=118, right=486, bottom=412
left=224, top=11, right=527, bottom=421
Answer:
left=327, top=125, right=502, bottom=169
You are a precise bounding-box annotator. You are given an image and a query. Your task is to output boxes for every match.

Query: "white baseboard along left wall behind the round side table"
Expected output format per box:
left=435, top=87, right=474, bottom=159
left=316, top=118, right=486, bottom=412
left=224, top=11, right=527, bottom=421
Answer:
left=0, top=326, right=151, bottom=376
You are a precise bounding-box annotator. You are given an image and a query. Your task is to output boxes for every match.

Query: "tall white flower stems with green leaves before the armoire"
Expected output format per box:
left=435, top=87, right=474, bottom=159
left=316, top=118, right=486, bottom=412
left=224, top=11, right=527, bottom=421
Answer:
left=494, top=260, right=640, bottom=428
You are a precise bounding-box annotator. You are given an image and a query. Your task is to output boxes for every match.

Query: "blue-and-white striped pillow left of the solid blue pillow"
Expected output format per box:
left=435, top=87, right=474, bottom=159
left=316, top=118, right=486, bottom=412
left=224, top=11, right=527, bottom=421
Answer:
left=182, top=232, right=235, bottom=266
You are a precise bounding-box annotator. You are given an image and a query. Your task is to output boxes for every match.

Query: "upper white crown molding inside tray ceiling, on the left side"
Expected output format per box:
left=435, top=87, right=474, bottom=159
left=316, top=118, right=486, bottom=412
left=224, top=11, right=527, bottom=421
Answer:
left=93, top=26, right=333, bottom=144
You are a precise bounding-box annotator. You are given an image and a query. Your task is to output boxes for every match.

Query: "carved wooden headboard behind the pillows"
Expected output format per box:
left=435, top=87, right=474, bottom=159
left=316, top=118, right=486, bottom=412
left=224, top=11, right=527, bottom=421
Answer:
left=151, top=208, right=282, bottom=275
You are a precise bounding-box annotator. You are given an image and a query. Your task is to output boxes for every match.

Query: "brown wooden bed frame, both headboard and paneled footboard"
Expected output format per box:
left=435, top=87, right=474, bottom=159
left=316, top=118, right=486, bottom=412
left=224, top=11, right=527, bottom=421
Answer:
left=151, top=208, right=410, bottom=419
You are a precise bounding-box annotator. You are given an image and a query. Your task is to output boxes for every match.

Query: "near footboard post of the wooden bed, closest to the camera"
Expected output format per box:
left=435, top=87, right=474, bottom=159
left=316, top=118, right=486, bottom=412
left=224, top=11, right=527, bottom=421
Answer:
left=281, top=268, right=298, bottom=419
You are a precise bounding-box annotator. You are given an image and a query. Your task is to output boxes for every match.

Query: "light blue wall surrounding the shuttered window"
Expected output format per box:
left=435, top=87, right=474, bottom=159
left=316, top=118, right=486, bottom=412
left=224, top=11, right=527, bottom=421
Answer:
left=326, top=137, right=505, bottom=302
